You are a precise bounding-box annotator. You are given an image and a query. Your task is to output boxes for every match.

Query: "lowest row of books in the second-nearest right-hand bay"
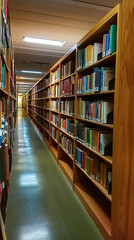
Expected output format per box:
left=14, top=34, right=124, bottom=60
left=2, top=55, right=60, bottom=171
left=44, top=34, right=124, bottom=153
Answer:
left=59, top=133, right=74, bottom=156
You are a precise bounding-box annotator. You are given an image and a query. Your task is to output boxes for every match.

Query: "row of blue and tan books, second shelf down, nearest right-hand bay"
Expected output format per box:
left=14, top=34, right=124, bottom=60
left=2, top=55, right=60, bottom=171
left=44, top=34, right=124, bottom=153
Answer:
left=77, top=67, right=115, bottom=94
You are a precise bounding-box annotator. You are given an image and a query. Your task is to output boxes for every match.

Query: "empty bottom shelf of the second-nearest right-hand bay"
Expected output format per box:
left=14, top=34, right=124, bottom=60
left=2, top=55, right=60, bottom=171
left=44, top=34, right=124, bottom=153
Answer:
left=58, top=160, right=73, bottom=186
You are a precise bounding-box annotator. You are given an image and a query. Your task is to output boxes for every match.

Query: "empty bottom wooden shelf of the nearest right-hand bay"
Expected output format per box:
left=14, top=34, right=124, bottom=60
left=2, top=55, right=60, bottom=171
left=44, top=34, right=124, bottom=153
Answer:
left=74, top=183, right=111, bottom=240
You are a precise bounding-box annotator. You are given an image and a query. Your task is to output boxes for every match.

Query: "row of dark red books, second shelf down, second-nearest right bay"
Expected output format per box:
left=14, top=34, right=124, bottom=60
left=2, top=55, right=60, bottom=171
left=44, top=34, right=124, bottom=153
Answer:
left=60, top=76, right=75, bottom=96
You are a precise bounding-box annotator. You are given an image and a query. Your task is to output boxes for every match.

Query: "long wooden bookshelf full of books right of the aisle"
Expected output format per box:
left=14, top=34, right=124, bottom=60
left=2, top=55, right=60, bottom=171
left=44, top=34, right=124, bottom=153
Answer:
left=28, top=4, right=121, bottom=239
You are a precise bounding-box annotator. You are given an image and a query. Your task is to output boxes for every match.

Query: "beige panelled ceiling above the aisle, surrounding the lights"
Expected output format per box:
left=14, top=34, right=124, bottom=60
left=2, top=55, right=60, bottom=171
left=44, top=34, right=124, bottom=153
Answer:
left=9, top=0, right=120, bottom=93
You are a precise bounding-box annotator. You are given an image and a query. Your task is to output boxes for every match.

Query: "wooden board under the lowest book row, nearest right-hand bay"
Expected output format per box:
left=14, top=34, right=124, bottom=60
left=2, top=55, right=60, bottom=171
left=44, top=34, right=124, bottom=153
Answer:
left=75, top=162, right=112, bottom=202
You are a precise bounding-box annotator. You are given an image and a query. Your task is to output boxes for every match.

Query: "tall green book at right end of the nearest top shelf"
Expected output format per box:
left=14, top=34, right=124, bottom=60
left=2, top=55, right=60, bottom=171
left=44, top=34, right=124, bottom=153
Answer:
left=110, top=25, right=117, bottom=54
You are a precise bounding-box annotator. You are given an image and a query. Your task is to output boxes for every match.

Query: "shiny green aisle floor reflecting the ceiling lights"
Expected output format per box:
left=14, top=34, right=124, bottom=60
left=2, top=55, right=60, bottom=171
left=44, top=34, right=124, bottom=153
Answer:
left=6, top=109, right=103, bottom=240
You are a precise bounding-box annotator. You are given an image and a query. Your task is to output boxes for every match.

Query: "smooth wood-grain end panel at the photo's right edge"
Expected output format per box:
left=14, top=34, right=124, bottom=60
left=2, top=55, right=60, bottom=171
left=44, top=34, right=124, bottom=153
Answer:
left=112, top=0, right=134, bottom=240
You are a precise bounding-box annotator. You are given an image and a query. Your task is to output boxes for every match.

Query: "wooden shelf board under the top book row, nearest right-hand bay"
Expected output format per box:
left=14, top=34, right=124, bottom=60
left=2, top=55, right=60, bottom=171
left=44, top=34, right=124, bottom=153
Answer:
left=78, top=52, right=116, bottom=73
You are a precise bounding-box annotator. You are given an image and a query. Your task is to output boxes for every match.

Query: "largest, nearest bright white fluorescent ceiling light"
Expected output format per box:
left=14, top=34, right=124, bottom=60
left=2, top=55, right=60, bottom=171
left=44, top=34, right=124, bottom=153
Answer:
left=23, top=37, right=65, bottom=47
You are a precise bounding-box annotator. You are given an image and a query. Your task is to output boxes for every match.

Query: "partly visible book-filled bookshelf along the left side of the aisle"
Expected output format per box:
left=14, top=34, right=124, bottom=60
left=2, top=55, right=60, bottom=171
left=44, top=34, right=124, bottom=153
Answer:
left=0, top=0, right=16, bottom=240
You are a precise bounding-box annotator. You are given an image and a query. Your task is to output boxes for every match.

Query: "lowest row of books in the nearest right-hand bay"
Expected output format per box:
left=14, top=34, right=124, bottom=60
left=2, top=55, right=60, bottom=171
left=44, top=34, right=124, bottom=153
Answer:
left=75, top=147, right=112, bottom=194
